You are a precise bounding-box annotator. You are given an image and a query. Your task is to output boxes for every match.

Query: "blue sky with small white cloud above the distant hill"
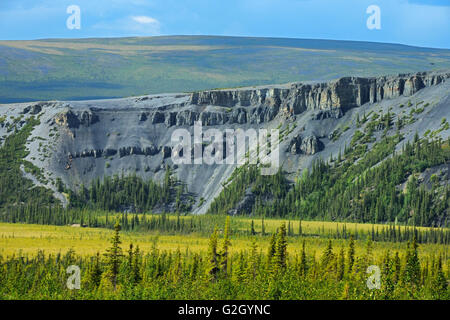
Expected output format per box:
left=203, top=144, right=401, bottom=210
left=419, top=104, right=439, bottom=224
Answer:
left=0, top=0, right=450, bottom=48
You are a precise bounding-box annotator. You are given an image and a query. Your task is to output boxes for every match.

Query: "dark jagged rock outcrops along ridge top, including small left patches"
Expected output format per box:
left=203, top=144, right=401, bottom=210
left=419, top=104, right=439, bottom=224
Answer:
left=50, top=73, right=450, bottom=132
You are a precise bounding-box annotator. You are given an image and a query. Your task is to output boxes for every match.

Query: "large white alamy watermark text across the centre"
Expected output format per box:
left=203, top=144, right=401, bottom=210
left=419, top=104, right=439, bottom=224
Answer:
left=171, top=121, right=280, bottom=175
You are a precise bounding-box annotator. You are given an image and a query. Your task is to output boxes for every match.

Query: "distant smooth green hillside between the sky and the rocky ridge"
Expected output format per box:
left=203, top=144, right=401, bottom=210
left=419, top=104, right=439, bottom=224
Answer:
left=0, top=36, right=450, bottom=103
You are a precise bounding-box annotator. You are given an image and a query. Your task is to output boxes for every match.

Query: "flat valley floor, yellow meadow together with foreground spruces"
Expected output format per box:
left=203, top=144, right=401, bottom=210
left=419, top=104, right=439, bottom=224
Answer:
left=0, top=215, right=450, bottom=300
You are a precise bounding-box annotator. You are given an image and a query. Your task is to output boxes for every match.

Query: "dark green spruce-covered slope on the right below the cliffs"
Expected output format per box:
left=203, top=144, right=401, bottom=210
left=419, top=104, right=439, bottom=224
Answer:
left=210, top=131, right=450, bottom=226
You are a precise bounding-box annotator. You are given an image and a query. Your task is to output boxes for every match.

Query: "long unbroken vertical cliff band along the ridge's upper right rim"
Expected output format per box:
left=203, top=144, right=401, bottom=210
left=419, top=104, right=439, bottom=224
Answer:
left=190, top=72, right=450, bottom=114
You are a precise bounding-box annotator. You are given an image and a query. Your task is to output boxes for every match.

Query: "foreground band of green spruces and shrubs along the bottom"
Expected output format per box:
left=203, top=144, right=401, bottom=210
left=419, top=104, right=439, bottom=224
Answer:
left=0, top=217, right=450, bottom=300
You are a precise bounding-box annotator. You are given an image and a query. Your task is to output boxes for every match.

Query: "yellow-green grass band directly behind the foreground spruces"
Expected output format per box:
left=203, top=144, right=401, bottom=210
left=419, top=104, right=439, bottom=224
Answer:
left=0, top=224, right=449, bottom=261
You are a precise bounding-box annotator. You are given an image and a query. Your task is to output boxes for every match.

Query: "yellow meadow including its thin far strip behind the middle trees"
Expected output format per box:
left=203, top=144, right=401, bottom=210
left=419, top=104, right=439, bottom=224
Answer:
left=0, top=219, right=450, bottom=261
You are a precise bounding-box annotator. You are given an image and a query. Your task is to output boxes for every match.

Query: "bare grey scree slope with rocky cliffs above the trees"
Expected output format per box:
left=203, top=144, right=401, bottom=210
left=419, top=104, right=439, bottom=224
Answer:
left=0, top=72, right=450, bottom=213
